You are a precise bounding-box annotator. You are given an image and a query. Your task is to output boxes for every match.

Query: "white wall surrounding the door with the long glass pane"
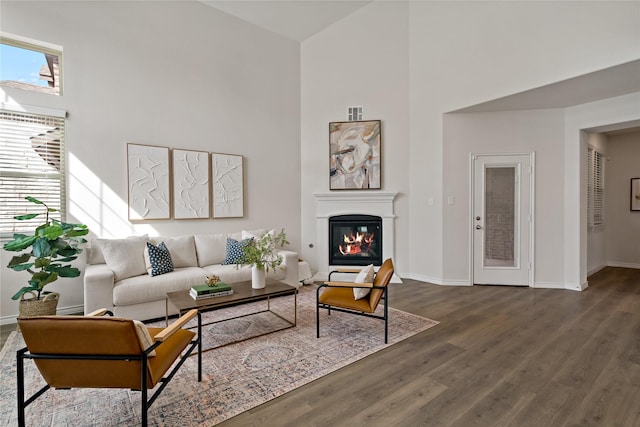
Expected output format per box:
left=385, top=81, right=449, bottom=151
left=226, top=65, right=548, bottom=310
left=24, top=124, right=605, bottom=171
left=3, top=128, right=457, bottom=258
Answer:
left=443, top=110, right=564, bottom=287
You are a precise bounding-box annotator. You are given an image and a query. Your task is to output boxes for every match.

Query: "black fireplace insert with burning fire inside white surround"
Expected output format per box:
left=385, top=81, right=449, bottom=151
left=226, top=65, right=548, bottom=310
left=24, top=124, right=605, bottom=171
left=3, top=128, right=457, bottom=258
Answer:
left=329, top=215, right=382, bottom=266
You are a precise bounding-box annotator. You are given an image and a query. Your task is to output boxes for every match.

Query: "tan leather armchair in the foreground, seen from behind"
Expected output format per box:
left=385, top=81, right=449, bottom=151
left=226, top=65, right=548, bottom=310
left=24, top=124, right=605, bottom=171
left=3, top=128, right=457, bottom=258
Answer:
left=16, top=309, right=202, bottom=426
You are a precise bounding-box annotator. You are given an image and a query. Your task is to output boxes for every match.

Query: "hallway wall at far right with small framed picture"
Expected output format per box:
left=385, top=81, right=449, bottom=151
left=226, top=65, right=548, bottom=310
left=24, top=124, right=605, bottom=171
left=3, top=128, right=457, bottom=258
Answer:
left=605, top=132, right=640, bottom=268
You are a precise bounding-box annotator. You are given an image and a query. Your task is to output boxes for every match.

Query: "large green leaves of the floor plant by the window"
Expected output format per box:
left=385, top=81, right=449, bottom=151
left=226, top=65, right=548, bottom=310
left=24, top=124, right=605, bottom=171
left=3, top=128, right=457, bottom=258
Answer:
left=3, top=197, right=89, bottom=300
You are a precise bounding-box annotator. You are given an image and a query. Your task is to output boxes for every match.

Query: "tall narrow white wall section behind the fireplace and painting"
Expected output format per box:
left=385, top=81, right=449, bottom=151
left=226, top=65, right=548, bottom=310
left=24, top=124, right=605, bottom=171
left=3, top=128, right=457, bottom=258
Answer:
left=301, top=2, right=411, bottom=272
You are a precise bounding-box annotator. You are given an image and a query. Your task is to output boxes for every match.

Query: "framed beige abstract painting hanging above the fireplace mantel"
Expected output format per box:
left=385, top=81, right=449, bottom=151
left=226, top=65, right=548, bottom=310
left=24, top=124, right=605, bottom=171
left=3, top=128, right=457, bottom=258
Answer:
left=329, top=120, right=382, bottom=190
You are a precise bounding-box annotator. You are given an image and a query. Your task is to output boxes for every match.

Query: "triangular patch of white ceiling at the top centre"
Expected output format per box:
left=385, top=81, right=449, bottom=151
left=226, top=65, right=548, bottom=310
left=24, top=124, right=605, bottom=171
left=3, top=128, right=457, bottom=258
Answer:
left=200, top=0, right=371, bottom=42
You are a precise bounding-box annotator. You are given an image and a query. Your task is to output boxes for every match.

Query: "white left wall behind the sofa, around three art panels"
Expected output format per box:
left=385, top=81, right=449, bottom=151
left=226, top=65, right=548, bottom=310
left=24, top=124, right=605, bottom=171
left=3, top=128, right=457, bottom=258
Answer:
left=0, top=1, right=300, bottom=319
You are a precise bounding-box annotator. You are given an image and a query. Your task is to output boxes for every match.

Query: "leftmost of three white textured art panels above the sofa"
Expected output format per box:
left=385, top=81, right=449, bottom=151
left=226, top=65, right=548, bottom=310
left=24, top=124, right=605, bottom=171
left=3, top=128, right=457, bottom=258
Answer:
left=127, top=144, right=171, bottom=221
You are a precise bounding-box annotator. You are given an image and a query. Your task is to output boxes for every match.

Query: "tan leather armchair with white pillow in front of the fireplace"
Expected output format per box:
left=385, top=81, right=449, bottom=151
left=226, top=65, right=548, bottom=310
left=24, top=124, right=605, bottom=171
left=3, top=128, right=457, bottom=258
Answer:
left=316, top=259, right=393, bottom=344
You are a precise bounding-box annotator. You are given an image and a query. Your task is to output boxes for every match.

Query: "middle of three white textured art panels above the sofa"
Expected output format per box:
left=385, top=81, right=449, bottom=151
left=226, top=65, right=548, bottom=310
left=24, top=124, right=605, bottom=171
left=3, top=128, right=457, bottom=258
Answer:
left=172, top=149, right=211, bottom=219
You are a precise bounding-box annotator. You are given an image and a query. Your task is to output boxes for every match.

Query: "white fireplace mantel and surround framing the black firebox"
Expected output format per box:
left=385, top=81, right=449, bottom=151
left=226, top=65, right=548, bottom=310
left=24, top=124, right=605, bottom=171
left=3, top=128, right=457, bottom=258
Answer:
left=313, top=191, right=398, bottom=280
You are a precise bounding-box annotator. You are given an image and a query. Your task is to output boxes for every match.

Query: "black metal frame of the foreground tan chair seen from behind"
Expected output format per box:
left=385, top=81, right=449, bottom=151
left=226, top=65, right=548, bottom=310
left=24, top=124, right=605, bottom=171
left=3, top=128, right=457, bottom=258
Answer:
left=16, top=311, right=202, bottom=427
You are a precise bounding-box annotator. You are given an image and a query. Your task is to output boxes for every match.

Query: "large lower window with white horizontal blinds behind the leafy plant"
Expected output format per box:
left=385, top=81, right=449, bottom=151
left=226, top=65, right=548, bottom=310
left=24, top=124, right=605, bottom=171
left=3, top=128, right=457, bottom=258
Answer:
left=0, top=109, right=66, bottom=238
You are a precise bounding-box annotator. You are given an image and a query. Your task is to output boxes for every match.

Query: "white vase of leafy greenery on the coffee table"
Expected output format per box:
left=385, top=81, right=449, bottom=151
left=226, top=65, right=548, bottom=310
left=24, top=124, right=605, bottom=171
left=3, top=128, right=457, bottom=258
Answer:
left=238, top=229, right=289, bottom=289
